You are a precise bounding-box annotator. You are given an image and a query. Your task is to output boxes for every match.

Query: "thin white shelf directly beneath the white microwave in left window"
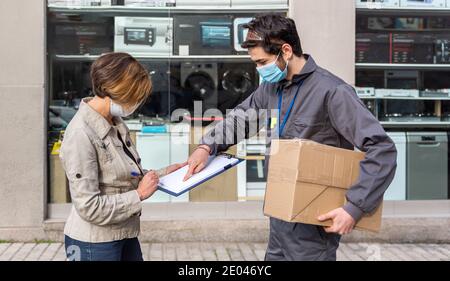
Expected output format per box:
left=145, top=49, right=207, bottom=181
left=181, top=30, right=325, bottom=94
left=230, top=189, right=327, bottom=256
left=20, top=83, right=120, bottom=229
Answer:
left=52, top=55, right=250, bottom=61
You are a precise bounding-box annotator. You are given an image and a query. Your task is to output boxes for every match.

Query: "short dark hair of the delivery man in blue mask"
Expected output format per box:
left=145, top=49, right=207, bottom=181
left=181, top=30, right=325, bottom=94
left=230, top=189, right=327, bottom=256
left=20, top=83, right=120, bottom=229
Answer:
left=242, top=14, right=303, bottom=57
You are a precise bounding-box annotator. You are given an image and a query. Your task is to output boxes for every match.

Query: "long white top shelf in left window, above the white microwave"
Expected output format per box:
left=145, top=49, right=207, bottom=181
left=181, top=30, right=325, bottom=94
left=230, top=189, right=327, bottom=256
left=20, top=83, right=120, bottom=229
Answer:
left=48, top=5, right=289, bottom=14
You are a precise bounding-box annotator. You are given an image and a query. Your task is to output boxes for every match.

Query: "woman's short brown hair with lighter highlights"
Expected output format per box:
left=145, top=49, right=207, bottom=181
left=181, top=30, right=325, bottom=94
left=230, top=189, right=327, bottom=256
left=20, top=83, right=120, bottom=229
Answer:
left=91, top=53, right=152, bottom=107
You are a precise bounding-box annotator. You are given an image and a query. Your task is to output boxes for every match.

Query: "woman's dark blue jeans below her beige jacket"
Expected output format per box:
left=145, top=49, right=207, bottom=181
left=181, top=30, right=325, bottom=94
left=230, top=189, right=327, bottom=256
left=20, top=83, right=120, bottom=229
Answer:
left=64, top=235, right=143, bottom=261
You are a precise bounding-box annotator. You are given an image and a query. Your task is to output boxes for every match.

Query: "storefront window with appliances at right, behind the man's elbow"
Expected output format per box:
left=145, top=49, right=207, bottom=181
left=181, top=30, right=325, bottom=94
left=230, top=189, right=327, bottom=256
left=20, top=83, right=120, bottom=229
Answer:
left=355, top=5, right=450, bottom=200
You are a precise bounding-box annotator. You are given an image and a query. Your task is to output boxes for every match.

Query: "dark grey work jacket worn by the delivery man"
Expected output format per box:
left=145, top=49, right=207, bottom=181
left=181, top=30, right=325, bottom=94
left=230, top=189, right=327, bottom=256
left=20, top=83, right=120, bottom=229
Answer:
left=201, top=55, right=397, bottom=221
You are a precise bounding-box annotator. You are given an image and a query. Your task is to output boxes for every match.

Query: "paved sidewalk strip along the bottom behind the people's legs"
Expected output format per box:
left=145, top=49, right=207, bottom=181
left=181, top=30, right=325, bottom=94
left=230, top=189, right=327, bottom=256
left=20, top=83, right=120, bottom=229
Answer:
left=0, top=242, right=450, bottom=261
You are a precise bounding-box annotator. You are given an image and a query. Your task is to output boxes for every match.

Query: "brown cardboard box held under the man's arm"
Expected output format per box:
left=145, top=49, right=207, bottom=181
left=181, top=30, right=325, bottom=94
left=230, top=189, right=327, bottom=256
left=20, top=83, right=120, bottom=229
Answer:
left=264, top=140, right=382, bottom=232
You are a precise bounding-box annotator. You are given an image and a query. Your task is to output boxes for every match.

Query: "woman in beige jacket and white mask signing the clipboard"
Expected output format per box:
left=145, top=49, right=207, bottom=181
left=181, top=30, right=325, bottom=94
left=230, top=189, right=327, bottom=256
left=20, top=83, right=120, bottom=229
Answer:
left=60, top=53, right=185, bottom=261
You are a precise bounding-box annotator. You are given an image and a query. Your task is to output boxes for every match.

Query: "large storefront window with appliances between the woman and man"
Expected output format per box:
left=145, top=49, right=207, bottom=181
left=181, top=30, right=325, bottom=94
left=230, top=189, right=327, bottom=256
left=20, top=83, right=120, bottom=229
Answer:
left=47, top=0, right=288, bottom=203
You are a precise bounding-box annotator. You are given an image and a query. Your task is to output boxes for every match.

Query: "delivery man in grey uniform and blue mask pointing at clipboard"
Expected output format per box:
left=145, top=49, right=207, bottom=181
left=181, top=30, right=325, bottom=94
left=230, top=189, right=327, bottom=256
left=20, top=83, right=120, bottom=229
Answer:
left=185, top=15, right=397, bottom=261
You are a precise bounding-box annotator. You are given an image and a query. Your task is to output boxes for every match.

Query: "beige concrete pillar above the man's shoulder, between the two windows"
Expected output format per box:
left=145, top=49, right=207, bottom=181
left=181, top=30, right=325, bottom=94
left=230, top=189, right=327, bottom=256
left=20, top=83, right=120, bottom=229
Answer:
left=289, top=0, right=356, bottom=85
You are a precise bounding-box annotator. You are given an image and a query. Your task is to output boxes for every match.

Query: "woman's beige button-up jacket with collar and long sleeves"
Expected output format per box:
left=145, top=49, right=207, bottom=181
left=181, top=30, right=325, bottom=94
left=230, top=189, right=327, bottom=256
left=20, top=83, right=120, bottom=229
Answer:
left=60, top=98, right=142, bottom=243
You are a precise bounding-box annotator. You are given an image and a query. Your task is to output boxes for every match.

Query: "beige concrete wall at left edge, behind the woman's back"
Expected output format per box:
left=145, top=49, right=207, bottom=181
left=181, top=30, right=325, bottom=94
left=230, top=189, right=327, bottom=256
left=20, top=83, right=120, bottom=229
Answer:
left=0, top=0, right=47, bottom=233
